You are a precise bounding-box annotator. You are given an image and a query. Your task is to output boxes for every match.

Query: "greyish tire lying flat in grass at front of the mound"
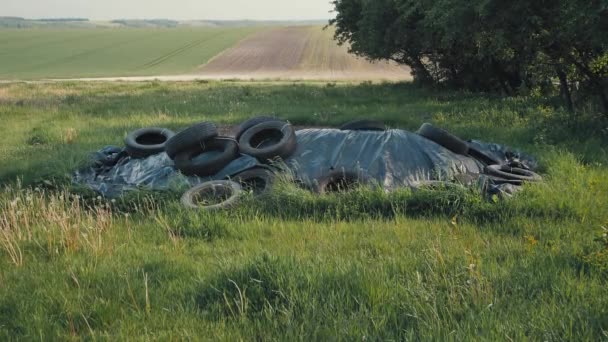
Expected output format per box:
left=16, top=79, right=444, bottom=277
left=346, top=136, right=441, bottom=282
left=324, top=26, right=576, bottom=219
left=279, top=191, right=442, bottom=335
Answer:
left=181, top=181, right=242, bottom=211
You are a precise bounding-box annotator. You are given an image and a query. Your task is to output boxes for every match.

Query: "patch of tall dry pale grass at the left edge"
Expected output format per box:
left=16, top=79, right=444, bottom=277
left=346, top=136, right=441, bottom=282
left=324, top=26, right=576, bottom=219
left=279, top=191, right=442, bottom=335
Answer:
left=0, top=186, right=114, bottom=266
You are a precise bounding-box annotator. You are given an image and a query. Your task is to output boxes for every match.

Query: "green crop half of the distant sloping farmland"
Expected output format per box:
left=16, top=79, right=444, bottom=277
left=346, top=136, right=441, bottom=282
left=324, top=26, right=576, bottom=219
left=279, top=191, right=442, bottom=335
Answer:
left=0, top=27, right=259, bottom=80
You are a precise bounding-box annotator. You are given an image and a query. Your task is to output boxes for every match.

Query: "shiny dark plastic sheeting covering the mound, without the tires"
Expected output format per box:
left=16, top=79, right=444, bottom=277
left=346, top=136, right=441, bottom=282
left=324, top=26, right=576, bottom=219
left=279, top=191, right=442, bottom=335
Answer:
left=74, top=129, right=536, bottom=198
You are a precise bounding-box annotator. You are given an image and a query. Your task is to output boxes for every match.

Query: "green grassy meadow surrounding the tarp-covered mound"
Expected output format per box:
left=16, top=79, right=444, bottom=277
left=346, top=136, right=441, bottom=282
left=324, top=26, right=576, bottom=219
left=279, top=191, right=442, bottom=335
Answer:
left=0, top=82, right=608, bottom=341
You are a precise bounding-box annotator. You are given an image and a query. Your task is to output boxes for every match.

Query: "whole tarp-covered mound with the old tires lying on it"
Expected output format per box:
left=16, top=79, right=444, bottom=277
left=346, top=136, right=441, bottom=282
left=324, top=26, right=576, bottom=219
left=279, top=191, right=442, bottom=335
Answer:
left=74, top=117, right=542, bottom=210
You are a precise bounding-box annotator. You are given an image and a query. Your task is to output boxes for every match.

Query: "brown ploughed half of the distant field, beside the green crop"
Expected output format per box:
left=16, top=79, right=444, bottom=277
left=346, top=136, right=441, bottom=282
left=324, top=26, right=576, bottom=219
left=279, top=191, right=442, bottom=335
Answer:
left=195, top=27, right=411, bottom=81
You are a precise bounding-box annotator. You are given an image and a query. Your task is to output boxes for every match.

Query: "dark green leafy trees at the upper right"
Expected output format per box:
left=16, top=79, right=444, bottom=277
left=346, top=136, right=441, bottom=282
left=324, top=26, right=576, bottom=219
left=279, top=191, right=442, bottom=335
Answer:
left=331, top=0, right=608, bottom=112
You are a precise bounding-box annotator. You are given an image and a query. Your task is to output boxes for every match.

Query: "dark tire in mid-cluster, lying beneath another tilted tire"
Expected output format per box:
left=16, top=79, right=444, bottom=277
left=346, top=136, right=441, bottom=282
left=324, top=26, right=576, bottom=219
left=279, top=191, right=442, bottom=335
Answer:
left=175, top=137, right=239, bottom=177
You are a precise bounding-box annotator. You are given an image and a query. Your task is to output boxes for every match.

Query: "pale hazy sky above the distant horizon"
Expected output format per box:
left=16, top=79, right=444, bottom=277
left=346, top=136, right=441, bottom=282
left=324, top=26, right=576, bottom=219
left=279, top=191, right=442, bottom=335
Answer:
left=0, top=0, right=332, bottom=20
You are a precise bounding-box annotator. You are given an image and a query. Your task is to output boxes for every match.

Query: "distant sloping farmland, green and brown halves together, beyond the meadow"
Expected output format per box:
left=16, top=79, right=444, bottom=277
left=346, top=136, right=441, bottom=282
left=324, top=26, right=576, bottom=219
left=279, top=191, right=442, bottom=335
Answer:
left=0, top=26, right=411, bottom=81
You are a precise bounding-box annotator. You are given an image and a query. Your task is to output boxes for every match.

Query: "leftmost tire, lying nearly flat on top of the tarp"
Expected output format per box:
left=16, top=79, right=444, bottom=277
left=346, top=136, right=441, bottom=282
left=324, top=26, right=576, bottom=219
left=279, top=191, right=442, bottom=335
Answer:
left=125, top=127, right=175, bottom=159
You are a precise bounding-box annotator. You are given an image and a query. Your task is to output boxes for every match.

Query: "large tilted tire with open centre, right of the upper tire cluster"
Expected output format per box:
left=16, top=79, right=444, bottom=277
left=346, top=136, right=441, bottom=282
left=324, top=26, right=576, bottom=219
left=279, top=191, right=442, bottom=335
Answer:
left=239, top=121, right=296, bottom=162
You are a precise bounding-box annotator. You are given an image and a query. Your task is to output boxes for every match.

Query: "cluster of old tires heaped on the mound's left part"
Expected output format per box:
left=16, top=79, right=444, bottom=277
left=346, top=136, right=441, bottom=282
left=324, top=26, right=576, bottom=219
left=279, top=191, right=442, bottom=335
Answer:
left=125, top=116, right=297, bottom=210
